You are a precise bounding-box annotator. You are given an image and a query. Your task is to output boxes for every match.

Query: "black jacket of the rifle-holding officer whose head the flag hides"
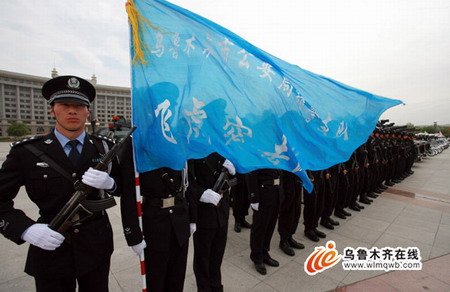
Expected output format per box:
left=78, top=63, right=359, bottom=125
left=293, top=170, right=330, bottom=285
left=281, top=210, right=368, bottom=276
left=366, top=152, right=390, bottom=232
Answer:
left=188, top=153, right=230, bottom=228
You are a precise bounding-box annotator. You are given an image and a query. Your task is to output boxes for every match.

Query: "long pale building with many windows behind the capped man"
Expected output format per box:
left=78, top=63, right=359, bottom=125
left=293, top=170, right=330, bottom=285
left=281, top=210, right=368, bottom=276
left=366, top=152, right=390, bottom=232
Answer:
left=0, top=69, right=131, bottom=137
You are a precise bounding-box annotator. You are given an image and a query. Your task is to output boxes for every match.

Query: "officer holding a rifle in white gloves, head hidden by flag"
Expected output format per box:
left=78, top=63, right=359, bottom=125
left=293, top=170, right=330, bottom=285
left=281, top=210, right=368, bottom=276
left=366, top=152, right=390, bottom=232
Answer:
left=188, top=153, right=236, bottom=291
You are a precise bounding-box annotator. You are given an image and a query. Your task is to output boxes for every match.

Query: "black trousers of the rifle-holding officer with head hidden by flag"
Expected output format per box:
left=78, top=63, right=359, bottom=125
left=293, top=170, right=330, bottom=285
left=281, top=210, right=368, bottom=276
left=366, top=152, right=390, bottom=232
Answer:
left=193, top=224, right=228, bottom=291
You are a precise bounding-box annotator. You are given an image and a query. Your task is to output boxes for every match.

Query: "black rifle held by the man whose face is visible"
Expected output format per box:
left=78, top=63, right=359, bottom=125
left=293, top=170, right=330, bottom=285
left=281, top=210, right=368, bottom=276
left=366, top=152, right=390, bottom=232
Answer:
left=48, top=127, right=136, bottom=235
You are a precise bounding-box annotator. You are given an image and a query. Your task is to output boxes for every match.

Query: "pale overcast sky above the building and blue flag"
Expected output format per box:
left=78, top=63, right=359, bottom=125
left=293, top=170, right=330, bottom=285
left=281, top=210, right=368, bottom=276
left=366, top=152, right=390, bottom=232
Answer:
left=0, top=0, right=450, bottom=125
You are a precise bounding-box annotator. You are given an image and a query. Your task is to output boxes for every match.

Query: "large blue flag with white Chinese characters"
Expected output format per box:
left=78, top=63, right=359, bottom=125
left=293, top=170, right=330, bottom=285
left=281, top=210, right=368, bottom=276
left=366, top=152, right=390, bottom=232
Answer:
left=126, top=0, right=401, bottom=191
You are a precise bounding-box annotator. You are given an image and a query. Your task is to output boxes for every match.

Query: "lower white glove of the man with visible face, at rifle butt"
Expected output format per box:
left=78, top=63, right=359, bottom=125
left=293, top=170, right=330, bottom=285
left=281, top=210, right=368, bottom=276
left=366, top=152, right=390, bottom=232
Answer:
left=21, top=223, right=64, bottom=250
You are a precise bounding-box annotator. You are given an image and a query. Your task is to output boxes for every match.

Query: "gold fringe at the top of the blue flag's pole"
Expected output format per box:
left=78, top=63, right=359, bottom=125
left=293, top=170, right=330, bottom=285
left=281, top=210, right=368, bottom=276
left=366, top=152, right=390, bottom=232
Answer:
left=125, top=0, right=161, bottom=65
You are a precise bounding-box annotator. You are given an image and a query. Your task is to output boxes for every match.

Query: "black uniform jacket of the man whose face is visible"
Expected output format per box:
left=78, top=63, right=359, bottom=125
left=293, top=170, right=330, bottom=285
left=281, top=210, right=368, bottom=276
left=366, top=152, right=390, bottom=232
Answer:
left=0, top=132, right=118, bottom=278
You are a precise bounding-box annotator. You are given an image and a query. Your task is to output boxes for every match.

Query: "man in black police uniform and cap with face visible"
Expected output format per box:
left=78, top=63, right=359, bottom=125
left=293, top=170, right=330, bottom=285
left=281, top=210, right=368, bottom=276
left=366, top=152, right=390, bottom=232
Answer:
left=0, top=76, right=120, bottom=292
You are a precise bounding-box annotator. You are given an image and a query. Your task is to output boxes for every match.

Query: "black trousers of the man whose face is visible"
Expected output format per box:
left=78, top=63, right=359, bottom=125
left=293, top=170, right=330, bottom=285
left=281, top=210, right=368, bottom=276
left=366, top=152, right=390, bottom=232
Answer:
left=34, top=259, right=110, bottom=292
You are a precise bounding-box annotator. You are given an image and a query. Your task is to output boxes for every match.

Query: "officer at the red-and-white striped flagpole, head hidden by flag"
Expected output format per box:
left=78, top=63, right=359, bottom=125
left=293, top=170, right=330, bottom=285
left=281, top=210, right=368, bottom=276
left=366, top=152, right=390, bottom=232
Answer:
left=120, top=140, right=196, bottom=292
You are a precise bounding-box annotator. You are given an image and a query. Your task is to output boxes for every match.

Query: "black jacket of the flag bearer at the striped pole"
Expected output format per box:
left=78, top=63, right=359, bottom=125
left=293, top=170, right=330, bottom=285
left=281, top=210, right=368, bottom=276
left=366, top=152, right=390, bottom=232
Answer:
left=120, top=140, right=190, bottom=251
